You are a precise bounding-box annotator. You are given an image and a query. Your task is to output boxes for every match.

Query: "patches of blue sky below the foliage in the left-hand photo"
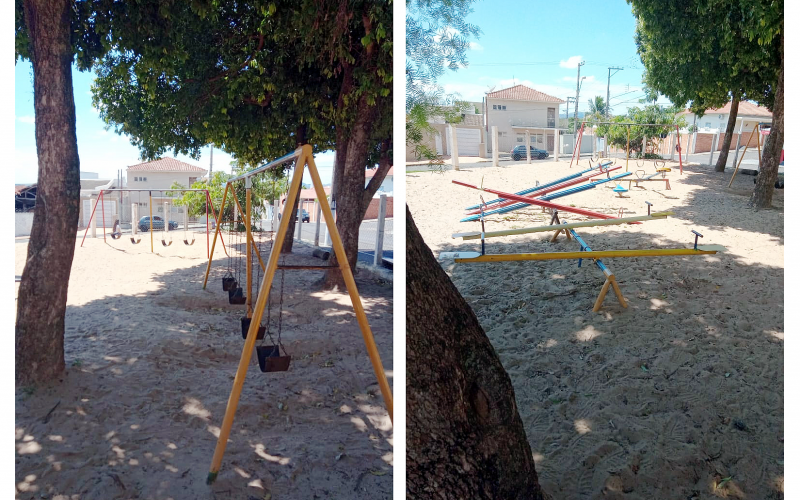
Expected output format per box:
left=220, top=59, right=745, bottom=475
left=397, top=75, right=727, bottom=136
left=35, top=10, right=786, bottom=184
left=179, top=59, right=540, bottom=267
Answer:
left=14, top=61, right=333, bottom=185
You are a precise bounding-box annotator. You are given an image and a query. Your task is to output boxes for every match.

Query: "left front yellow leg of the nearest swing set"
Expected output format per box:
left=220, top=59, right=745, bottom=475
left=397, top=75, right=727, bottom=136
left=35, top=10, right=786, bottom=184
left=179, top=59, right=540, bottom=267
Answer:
left=206, top=146, right=311, bottom=484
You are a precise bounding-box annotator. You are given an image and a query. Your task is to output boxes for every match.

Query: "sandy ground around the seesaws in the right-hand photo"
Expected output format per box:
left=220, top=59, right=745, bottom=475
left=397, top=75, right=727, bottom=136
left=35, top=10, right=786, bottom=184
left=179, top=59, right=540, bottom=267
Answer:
left=406, top=160, right=784, bottom=500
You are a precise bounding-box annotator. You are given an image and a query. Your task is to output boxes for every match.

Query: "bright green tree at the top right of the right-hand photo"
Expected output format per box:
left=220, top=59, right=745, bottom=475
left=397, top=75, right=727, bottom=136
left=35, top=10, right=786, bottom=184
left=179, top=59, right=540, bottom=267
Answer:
left=628, top=0, right=783, bottom=176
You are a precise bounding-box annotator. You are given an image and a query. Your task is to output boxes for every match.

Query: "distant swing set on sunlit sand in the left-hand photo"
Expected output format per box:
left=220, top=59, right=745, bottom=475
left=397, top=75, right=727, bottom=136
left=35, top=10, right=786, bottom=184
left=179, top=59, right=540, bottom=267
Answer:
left=81, top=188, right=220, bottom=257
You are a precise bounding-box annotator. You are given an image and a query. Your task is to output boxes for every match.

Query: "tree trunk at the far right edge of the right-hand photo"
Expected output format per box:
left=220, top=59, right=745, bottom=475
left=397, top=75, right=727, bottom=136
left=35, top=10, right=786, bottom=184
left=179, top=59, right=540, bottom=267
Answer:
left=748, top=35, right=783, bottom=208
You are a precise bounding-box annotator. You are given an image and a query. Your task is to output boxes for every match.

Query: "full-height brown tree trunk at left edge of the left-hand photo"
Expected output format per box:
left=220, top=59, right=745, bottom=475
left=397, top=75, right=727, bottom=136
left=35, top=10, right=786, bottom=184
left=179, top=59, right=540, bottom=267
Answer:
left=15, top=0, right=80, bottom=385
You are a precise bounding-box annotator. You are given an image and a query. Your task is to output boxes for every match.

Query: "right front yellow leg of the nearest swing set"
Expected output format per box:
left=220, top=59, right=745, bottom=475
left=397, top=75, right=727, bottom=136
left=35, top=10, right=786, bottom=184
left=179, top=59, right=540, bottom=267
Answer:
left=303, top=150, right=394, bottom=423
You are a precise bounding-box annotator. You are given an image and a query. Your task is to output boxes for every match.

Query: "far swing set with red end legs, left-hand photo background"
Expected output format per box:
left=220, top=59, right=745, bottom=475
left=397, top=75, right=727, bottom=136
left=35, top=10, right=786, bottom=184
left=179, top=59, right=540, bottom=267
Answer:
left=81, top=188, right=227, bottom=258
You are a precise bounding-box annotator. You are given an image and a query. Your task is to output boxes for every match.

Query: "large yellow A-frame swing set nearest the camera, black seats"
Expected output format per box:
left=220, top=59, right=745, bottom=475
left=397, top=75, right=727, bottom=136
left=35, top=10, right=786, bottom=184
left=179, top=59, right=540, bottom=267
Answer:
left=203, top=145, right=393, bottom=484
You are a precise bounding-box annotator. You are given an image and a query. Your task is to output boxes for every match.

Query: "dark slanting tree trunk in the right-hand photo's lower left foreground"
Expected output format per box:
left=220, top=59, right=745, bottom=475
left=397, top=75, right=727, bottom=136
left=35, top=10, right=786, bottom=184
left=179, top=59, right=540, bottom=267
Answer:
left=406, top=207, right=549, bottom=500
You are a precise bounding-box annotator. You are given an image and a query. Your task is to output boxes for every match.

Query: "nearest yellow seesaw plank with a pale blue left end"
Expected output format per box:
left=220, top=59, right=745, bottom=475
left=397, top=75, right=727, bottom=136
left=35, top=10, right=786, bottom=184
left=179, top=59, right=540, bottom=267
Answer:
left=439, top=248, right=724, bottom=264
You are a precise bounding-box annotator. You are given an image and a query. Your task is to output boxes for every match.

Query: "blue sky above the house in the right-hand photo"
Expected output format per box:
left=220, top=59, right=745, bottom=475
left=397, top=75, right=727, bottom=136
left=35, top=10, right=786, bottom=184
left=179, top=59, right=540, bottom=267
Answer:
left=438, top=0, right=669, bottom=116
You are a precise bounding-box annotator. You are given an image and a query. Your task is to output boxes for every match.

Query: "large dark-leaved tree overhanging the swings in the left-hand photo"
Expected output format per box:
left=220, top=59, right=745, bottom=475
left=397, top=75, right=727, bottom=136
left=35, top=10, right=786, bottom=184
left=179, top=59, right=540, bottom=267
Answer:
left=93, top=0, right=392, bottom=280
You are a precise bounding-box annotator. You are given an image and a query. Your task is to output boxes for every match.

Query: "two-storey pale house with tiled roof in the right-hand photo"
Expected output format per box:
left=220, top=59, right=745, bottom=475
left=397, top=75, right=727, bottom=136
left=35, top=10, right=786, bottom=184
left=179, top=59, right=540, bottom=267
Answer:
left=484, top=85, right=566, bottom=153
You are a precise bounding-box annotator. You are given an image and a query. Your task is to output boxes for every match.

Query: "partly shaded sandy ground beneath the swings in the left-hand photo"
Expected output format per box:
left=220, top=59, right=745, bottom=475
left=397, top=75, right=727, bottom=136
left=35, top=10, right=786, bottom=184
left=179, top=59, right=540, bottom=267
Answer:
left=16, top=235, right=393, bottom=500
